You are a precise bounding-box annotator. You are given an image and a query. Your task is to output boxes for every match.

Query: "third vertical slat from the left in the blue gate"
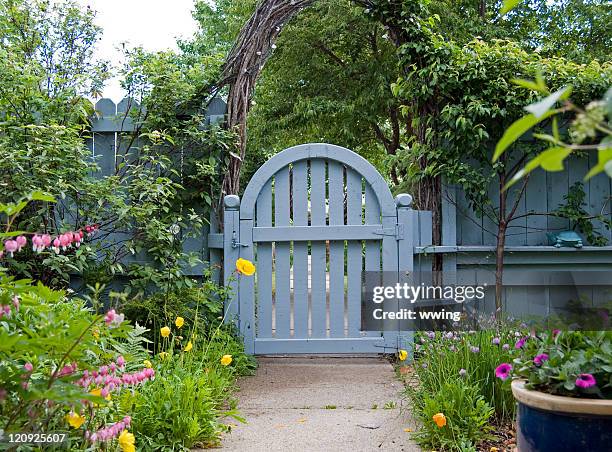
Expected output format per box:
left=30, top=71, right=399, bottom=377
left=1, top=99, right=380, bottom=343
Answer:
left=292, top=160, right=308, bottom=338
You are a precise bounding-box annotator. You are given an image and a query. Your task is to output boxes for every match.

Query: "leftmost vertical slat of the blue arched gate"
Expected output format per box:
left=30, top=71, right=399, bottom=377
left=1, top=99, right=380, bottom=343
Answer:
left=257, top=180, right=272, bottom=337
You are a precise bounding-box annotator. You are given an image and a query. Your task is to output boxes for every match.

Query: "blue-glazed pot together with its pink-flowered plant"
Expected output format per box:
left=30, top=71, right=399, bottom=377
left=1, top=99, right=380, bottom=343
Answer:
left=495, top=330, right=612, bottom=452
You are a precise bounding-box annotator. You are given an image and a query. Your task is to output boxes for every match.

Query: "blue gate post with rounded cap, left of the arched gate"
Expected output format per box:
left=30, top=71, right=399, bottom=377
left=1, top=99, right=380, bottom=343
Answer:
left=223, top=195, right=240, bottom=326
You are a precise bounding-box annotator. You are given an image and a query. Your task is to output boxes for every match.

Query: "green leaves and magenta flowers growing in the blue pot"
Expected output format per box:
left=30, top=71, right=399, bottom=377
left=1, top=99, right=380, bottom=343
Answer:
left=502, top=331, right=612, bottom=399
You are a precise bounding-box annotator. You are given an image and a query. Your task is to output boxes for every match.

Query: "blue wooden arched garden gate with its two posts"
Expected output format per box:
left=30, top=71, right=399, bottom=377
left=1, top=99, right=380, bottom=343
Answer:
left=223, top=144, right=415, bottom=355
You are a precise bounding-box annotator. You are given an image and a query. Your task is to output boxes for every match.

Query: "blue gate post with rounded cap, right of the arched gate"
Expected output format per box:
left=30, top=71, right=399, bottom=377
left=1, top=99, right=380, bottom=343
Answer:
left=395, top=193, right=418, bottom=360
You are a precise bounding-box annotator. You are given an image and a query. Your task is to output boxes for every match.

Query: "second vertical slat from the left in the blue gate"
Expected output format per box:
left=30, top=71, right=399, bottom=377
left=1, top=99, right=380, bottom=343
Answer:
left=274, top=167, right=291, bottom=338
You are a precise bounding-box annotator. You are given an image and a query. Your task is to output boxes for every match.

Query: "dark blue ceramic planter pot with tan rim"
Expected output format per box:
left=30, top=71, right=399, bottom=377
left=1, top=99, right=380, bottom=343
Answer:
left=512, top=381, right=612, bottom=452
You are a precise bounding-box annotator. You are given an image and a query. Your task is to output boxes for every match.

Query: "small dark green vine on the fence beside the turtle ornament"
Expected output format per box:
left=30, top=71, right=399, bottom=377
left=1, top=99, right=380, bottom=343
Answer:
left=552, top=182, right=612, bottom=246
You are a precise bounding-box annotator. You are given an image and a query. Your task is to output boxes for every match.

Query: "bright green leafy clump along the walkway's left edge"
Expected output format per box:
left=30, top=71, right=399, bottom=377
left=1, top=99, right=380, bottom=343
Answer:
left=119, top=316, right=254, bottom=450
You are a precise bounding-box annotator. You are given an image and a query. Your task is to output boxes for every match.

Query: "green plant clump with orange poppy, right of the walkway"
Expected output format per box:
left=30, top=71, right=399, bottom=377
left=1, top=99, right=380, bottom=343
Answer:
left=408, top=381, right=494, bottom=451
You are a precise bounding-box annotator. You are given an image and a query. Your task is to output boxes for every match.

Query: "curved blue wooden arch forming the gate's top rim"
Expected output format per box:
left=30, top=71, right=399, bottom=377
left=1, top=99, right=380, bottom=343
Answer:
left=240, top=143, right=396, bottom=219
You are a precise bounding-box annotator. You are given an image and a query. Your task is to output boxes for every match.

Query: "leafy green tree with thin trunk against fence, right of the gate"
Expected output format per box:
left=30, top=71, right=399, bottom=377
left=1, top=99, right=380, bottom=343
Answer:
left=352, top=2, right=612, bottom=309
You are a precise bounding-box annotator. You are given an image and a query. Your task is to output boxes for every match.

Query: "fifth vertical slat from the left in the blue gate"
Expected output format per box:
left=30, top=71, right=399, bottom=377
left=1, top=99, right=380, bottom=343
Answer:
left=328, top=162, right=344, bottom=337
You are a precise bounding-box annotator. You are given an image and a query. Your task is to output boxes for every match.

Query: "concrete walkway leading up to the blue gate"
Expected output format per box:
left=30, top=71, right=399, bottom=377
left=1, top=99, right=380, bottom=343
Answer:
left=222, top=357, right=420, bottom=452
